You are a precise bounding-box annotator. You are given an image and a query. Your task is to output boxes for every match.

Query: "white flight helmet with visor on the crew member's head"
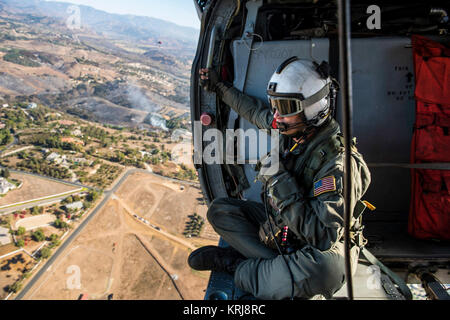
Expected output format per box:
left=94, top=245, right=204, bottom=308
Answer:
left=267, top=57, right=336, bottom=126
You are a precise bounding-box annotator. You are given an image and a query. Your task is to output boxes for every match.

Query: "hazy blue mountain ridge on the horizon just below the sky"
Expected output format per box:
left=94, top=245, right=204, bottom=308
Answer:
left=0, top=0, right=199, bottom=46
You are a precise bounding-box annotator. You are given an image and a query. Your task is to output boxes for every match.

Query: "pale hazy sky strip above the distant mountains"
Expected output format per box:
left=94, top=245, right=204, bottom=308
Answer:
left=47, top=0, right=200, bottom=29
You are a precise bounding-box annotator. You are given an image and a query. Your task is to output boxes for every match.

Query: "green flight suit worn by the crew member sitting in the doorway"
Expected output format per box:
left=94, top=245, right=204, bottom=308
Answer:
left=208, top=83, right=370, bottom=299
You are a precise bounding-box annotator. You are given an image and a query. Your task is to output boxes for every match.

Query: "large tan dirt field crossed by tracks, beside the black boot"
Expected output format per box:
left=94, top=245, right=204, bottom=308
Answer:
left=24, top=173, right=219, bottom=300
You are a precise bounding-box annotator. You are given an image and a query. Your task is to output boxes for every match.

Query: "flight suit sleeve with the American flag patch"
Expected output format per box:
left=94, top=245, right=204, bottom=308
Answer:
left=281, top=155, right=370, bottom=250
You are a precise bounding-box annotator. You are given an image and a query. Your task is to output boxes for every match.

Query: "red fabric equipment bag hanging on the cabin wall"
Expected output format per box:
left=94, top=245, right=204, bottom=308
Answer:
left=408, top=36, right=450, bottom=240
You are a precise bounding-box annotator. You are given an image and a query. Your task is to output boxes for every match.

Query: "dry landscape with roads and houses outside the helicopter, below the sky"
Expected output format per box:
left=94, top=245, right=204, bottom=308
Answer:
left=0, top=0, right=219, bottom=300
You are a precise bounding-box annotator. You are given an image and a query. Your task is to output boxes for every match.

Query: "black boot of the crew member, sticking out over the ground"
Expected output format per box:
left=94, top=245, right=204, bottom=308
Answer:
left=188, top=246, right=245, bottom=274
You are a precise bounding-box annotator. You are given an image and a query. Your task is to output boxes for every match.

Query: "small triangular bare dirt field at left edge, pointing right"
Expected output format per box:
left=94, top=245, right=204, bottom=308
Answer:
left=0, top=173, right=78, bottom=206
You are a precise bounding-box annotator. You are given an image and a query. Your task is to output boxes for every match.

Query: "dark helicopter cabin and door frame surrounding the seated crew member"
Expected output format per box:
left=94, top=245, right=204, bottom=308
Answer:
left=190, top=0, right=450, bottom=300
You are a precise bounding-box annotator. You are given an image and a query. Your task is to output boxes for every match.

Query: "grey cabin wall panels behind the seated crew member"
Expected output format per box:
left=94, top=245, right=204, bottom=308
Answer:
left=231, top=37, right=415, bottom=221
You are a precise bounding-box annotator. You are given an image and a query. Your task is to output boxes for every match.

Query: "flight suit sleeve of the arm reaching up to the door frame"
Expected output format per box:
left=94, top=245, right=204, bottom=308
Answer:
left=217, top=82, right=273, bottom=131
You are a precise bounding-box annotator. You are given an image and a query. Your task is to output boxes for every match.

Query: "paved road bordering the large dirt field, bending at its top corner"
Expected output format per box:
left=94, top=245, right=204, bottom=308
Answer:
left=15, top=169, right=199, bottom=300
